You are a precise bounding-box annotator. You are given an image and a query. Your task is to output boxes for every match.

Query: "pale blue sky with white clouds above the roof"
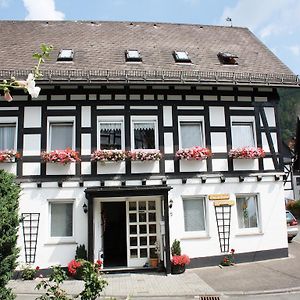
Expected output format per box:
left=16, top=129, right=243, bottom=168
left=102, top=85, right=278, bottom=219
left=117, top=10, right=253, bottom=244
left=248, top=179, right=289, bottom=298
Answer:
left=0, top=0, right=300, bottom=75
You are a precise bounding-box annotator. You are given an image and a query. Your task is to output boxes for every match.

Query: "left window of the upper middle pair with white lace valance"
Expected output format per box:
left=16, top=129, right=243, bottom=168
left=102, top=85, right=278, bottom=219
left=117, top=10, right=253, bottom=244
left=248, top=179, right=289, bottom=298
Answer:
left=98, top=121, right=124, bottom=150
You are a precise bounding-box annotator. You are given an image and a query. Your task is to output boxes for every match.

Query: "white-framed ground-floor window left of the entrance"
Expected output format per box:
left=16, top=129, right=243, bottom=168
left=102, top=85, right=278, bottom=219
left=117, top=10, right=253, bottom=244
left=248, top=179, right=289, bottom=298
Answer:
left=48, top=199, right=74, bottom=241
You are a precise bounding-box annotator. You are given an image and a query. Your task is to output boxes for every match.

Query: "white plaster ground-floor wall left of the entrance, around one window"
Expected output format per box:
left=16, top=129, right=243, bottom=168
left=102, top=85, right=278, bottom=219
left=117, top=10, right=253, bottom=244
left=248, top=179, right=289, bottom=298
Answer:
left=18, top=187, right=87, bottom=268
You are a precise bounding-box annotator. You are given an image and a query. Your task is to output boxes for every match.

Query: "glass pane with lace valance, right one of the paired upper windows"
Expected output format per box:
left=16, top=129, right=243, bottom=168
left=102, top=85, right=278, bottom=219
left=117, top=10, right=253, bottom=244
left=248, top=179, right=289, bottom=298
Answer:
left=134, top=122, right=155, bottom=149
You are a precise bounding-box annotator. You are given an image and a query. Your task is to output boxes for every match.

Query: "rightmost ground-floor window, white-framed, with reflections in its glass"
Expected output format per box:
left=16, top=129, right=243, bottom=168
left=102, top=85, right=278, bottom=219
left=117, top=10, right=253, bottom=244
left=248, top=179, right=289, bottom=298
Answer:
left=236, top=194, right=260, bottom=232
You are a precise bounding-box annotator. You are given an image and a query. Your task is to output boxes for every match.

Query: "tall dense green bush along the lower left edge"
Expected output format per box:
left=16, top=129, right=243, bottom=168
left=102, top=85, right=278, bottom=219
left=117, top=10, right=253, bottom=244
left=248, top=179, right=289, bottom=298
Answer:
left=0, top=170, right=20, bottom=300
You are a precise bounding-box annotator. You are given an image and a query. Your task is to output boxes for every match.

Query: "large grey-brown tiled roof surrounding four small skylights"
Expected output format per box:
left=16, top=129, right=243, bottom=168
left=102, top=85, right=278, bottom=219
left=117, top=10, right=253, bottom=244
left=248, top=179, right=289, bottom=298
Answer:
left=0, top=21, right=299, bottom=84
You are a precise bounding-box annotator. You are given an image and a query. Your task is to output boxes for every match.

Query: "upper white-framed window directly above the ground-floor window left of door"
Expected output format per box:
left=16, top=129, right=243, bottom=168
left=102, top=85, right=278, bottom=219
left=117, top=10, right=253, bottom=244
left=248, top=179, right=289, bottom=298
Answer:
left=47, top=117, right=75, bottom=151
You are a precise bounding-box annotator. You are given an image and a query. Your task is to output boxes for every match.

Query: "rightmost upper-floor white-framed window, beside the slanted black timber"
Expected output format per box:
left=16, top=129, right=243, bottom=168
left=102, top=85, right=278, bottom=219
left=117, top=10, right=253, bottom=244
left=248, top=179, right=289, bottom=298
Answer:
left=231, top=117, right=256, bottom=148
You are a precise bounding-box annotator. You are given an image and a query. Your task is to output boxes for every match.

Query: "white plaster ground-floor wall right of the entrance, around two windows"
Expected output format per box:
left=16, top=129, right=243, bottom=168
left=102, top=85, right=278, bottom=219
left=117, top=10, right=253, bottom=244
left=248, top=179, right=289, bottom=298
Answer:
left=169, top=182, right=287, bottom=257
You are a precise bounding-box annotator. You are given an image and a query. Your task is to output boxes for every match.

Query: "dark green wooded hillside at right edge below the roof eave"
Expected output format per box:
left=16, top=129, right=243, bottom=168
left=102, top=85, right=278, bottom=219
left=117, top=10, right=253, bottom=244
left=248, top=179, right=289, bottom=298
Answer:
left=278, top=88, right=300, bottom=143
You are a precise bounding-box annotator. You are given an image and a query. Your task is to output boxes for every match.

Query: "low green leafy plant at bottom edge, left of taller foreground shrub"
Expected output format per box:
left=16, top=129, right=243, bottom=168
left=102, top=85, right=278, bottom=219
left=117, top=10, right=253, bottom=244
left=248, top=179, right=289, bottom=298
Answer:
left=35, top=266, right=72, bottom=300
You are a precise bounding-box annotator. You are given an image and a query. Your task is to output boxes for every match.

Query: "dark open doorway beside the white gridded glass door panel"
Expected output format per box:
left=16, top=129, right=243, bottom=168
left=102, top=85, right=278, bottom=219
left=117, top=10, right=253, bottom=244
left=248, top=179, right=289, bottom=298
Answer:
left=101, top=202, right=127, bottom=268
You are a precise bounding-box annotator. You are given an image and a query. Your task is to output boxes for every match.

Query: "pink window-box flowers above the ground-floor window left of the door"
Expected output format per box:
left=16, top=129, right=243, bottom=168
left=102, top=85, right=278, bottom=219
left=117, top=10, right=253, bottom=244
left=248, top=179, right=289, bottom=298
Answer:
left=42, top=148, right=80, bottom=165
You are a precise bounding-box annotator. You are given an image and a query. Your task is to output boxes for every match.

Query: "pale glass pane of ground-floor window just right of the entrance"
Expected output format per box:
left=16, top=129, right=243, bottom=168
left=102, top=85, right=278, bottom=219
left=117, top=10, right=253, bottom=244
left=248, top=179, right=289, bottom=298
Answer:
left=183, top=199, right=205, bottom=231
